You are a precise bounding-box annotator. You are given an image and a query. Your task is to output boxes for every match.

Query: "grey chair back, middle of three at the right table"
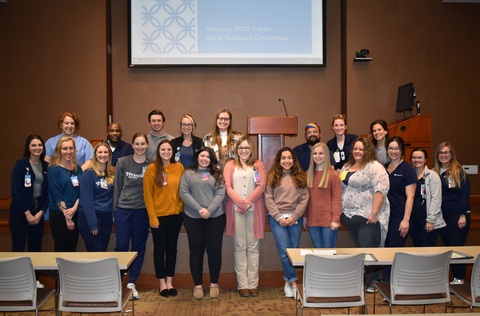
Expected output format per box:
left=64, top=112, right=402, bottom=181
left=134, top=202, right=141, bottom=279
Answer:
left=390, top=251, right=452, bottom=305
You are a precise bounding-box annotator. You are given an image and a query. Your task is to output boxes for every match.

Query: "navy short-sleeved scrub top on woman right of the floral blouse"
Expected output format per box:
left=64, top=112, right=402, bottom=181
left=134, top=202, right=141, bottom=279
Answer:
left=385, top=160, right=418, bottom=221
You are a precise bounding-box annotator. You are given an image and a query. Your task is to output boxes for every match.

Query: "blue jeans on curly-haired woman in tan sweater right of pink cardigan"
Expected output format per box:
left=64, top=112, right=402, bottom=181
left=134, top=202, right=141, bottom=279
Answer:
left=268, top=216, right=303, bottom=283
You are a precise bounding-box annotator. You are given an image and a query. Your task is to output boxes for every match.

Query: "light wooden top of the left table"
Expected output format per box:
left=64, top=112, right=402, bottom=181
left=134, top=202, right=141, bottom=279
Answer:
left=0, top=251, right=137, bottom=270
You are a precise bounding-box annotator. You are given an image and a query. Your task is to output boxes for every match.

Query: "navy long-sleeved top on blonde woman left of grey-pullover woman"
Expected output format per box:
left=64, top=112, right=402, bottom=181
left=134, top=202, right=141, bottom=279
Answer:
left=79, top=169, right=113, bottom=231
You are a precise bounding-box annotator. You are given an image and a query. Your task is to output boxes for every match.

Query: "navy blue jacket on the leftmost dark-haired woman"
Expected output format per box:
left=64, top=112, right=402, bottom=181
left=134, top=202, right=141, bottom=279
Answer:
left=10, top=158, right=48, bottom=215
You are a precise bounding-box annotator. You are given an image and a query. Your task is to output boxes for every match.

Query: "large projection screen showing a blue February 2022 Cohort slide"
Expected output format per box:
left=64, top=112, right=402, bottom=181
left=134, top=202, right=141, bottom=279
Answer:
left=128, top=0, right=326, bottom=67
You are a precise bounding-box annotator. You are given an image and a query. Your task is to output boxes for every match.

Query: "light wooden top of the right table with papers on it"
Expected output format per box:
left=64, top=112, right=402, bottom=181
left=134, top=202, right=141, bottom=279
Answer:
left=287, top=246, right=480, bottom=267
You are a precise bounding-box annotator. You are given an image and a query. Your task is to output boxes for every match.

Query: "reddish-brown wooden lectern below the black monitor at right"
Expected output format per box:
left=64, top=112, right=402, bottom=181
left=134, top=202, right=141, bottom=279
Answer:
left=388, top=115, right=435, bottom=167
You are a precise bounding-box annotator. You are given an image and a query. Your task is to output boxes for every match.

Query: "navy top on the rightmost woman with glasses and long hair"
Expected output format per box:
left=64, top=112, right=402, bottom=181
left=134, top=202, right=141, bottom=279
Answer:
left=440, top=170, right=470, bottom=215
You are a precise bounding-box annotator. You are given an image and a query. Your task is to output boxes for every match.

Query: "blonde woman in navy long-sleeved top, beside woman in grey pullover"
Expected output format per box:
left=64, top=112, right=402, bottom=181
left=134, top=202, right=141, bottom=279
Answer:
left=78, top=143, right=115, bottom=251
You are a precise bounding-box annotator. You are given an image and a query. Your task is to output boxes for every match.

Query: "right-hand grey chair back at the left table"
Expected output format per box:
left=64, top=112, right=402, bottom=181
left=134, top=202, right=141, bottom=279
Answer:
left=56, top=258, right=122, bottom=313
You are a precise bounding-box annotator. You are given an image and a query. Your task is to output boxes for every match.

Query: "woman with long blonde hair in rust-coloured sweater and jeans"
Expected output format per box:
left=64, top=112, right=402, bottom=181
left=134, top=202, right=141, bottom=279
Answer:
left=303, top=143, right=342, bottom=248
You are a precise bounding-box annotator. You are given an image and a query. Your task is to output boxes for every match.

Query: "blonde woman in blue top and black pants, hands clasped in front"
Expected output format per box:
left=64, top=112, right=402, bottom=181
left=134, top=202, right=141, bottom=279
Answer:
left=48, top=137, right=83, bottom=252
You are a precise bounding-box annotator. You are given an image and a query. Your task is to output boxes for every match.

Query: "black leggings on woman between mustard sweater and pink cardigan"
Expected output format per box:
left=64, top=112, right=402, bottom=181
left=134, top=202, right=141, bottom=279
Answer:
left=183, top=214, right=226, bottom=285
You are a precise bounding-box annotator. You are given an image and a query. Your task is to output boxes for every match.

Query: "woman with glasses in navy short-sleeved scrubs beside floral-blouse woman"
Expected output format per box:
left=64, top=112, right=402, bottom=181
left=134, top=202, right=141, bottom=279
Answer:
left=383, top=136, right=417, bottom=281
